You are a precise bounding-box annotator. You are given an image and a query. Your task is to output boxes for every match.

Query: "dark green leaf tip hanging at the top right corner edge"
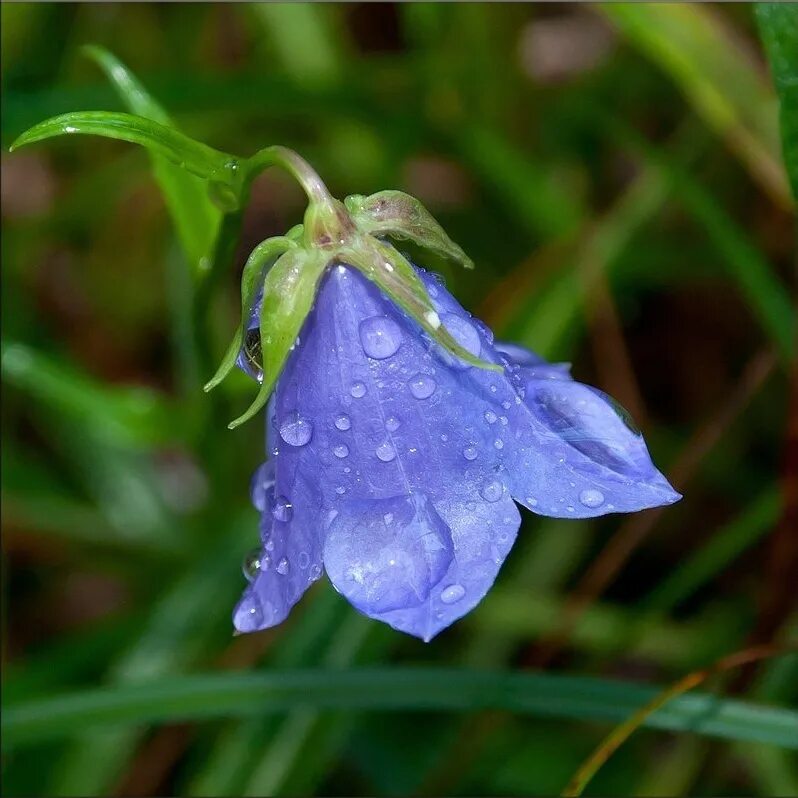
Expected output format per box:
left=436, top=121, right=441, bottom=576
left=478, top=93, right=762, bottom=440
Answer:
left=754, top=3, right=798, bottom=200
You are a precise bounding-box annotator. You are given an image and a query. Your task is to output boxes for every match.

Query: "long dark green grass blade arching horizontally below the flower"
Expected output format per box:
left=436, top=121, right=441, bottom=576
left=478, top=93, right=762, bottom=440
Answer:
left=2, top=668, right=798, bottom=750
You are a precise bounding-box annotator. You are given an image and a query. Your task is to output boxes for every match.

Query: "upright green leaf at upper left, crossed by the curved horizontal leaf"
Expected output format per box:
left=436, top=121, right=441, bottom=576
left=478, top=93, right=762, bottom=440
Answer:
left=83, top=45, right=222, bottom=275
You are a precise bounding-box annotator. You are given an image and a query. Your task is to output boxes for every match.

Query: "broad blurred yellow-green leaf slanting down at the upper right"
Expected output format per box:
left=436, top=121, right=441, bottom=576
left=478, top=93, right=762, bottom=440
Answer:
left=599, top=3, right=792, bottom=208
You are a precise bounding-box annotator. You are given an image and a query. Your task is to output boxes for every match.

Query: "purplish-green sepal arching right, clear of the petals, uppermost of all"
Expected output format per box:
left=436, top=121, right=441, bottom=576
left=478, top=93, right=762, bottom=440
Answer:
left=344, top=191, right=474, bottom=269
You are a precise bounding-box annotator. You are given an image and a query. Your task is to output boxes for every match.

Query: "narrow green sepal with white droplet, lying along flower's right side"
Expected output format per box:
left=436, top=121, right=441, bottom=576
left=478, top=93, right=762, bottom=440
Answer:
left=337, top=236, right=502, bottom=371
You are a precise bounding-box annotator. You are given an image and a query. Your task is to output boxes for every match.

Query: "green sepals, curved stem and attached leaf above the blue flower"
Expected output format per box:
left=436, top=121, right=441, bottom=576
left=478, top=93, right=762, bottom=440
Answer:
left=12, top=90, right=501, bottom=428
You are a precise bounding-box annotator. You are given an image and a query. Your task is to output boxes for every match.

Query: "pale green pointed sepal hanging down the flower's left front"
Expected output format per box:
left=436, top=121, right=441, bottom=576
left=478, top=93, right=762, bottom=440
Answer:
left=227, top=247, right=329, bottom=429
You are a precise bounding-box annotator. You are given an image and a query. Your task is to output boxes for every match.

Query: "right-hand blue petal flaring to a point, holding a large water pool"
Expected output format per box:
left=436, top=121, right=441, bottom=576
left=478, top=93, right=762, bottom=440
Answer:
left=422, top=274, right=680, bottom=518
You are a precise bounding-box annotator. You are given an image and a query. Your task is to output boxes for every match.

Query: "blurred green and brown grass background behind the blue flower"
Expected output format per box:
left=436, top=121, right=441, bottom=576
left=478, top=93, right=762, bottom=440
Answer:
left=2, top=3, right=798, bottom=795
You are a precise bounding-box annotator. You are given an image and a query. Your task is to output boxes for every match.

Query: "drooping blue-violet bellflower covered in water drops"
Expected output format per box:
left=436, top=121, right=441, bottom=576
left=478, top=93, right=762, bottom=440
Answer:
left=234, top=264, right=680, bottom=641
